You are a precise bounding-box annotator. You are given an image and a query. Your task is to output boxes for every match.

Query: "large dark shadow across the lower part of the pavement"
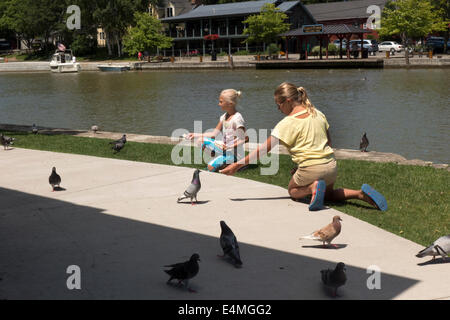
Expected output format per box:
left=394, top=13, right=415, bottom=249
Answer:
left=0, top=188, right=418, bottom=300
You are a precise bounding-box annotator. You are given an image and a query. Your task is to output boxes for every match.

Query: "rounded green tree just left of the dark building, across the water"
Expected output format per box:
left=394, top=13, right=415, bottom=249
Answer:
left=123, top=12, right=172, bottom=55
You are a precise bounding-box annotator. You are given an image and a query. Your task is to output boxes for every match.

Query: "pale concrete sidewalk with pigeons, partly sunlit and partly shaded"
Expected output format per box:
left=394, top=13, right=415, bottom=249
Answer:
left=0, top=148, right=450, bottom=300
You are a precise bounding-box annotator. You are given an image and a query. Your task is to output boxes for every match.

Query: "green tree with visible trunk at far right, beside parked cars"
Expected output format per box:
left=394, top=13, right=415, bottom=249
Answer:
left=380, top=0, right=448, bottom=64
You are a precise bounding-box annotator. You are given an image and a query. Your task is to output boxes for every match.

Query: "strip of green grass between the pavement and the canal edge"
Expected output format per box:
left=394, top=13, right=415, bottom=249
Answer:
left=5, top=132, right=450, bottom=246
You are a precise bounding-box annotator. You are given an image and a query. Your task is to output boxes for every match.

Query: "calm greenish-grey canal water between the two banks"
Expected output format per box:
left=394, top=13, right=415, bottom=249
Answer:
left=0, top=69, right=450, bottom=163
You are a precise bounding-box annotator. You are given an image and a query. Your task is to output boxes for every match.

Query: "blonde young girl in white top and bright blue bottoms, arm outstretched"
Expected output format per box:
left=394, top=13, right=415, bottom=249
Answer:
left=186, top=89, right=248, bottom=171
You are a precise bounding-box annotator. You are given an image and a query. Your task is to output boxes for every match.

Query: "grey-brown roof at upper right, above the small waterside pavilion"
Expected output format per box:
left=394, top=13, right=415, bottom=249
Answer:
left=305, top=0, right=387, bottom=22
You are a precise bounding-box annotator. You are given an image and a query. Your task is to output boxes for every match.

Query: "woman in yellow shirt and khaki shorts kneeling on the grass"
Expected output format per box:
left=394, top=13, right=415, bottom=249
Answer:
left=220, top=82, right=387, bottom=211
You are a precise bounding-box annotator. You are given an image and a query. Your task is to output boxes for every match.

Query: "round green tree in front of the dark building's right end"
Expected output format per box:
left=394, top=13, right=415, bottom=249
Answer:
left=242, top=3, right=290, bottom=50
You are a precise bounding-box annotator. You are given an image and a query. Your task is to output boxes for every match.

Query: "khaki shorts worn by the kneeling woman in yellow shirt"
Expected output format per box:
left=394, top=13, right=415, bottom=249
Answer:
left=293, top=159, right=337, bottom=187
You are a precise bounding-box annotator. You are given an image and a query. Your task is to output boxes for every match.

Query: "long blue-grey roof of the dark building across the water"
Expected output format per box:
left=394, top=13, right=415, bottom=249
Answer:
left=161, top=0, right=299, bottom=22
